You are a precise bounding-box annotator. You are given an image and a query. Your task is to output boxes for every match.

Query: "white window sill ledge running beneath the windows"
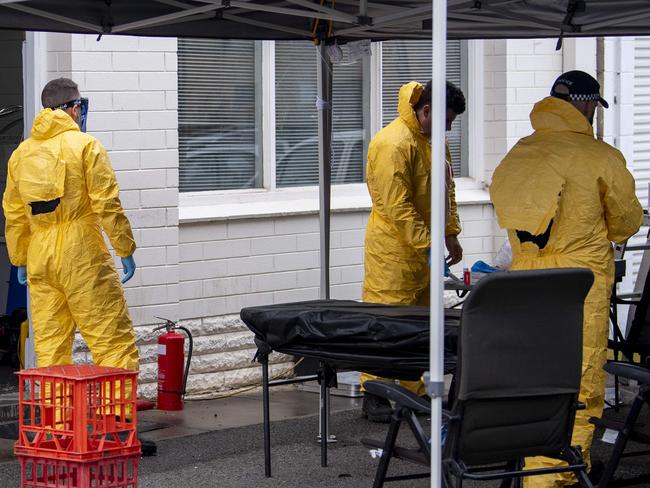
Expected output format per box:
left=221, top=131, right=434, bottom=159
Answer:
left=179, top=178, right=490, bottom=224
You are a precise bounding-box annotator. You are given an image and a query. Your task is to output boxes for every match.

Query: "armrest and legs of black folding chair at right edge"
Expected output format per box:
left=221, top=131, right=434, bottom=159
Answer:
left=592, top=362, right=650, bottom=488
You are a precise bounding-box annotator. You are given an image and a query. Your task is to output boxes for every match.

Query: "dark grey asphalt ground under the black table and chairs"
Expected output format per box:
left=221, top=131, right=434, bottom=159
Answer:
left=0, top=392, right=650, bottom=488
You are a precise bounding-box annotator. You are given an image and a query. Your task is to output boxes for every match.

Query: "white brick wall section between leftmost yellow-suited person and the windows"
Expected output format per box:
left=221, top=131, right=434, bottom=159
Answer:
left=47, top=34, right=179, bottom=395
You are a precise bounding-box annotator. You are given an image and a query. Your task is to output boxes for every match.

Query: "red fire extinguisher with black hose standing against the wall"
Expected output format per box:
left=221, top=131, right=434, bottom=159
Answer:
left=154, top=317, right=194, bottom=410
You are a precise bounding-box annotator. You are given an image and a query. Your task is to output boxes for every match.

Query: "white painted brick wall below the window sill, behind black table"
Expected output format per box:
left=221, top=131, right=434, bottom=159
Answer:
left=180, top=204, right=494, bottom=314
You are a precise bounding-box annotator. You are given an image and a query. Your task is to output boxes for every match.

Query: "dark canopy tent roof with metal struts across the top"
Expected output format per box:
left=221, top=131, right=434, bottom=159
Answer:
left=0, top=0, right=650, bottom=42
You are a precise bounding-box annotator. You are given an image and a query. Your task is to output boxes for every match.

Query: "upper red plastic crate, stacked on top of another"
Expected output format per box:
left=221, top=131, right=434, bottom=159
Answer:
left=14, top=365, right=140, bottom=462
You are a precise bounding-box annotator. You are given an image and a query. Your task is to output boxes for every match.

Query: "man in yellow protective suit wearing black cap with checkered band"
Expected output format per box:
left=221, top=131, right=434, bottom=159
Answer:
left=490, top=71, right=643, bottom=487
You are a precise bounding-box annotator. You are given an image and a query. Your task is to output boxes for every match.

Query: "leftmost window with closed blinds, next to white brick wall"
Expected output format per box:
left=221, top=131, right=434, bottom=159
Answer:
left=178, top=39, right=261, bottom=192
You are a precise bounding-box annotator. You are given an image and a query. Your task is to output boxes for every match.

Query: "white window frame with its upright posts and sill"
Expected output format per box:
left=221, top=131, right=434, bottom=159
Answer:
left=179, top=40, right=489, bottom=223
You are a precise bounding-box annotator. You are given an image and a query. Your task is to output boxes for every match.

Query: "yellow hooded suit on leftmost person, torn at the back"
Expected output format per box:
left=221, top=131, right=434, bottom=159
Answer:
left=2, top=109, right=138, bottom=370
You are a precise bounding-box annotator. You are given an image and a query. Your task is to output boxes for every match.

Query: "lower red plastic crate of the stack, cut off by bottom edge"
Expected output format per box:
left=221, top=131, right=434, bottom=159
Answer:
left=18, top=454, right=140, bottom=488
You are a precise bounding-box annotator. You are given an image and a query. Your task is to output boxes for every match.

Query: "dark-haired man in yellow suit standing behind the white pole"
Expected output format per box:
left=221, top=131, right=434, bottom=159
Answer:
left=359, top=81, right=465, bottom=422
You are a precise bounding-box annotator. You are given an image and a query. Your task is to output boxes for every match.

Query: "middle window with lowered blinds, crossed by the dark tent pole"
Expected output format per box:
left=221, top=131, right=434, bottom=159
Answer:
left=275, top=41, right=364, bottom=187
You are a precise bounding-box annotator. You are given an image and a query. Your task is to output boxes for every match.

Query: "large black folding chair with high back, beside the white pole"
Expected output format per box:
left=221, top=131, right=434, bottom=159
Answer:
left=362, top=269, right=593, bottom=488
